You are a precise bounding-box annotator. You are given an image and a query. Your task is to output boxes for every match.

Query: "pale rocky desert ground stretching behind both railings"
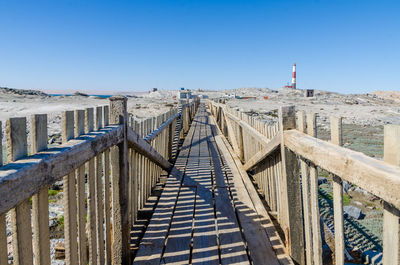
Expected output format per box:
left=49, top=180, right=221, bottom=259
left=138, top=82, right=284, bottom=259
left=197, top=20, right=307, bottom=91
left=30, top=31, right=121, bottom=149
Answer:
left=0, top=88, right=400, bottom=264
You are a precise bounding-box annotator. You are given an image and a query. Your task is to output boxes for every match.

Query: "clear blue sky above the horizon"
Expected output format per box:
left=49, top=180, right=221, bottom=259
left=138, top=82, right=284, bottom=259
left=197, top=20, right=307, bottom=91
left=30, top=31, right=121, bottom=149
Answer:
left=0, top=0, right=400, bottom=93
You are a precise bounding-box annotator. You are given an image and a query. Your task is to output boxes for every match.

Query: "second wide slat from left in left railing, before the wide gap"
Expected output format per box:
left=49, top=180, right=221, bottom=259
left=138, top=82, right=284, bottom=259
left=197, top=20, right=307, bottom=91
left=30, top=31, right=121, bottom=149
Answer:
left=30, top=114, right=50, bottom=265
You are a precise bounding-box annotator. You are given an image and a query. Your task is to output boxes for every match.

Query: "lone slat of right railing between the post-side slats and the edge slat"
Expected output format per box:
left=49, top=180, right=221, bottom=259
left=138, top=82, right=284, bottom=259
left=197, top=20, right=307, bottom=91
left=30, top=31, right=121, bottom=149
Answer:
left=330, top=117, right=344, bottom=265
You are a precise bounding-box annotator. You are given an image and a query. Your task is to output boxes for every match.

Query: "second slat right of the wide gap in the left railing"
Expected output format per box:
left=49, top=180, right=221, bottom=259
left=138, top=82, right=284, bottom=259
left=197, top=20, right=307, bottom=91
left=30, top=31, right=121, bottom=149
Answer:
left=75, top=110, right=88, bottom=265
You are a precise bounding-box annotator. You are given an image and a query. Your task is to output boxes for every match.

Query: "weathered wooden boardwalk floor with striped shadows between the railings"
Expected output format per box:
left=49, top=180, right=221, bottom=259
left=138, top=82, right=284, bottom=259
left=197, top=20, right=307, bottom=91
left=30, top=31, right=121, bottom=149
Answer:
left=133, top=104, right=291, bottom=264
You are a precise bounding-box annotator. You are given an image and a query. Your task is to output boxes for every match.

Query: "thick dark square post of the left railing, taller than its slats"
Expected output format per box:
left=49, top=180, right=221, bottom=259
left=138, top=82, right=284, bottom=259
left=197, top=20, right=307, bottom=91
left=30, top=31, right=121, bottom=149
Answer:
left=110, top=96, right=130, bottom=264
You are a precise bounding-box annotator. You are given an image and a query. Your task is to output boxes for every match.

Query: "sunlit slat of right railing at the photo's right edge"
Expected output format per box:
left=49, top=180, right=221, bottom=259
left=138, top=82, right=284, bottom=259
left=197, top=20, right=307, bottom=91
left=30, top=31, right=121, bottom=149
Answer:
left=383, top=125, right=400, bottom=265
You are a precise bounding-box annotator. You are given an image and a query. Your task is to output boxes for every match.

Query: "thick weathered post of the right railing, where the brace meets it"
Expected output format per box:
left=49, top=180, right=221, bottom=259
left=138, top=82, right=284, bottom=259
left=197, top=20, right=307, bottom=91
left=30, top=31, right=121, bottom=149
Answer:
left=279, top=106, right=305, bottom=264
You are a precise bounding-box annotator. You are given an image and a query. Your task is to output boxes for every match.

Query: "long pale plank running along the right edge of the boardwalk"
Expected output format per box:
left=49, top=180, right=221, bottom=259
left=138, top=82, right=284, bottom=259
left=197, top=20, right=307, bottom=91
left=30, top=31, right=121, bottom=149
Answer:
left=211, top=112, right=293, bottom=264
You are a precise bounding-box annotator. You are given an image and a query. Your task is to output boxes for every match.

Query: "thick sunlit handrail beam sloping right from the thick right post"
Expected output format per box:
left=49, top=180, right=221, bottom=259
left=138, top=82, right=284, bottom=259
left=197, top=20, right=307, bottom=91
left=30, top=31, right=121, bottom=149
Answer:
left=284, top=130, right=400, bottom=208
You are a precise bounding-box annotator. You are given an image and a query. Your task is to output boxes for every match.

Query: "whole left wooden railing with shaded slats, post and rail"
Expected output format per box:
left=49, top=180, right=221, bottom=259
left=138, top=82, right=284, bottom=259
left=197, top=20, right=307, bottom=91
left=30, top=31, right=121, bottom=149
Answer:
left=0, top=96, right=198, bottom=265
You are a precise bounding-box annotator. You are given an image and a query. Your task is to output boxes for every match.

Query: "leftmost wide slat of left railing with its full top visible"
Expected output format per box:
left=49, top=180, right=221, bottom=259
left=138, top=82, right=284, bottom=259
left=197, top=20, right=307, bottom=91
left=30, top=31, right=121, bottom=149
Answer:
left=7, top=118, right=33, bottom=265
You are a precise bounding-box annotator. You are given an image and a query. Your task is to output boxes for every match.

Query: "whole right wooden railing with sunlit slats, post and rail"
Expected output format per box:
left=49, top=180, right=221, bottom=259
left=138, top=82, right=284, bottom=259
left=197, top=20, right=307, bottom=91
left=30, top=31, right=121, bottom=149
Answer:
left=208, top=101, right=400, bottom=265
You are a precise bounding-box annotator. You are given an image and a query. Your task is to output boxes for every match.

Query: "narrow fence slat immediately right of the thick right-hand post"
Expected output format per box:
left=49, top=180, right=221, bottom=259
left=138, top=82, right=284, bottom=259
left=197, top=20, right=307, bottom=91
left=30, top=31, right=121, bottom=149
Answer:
left=297, top=111, right=313, bottom=264
